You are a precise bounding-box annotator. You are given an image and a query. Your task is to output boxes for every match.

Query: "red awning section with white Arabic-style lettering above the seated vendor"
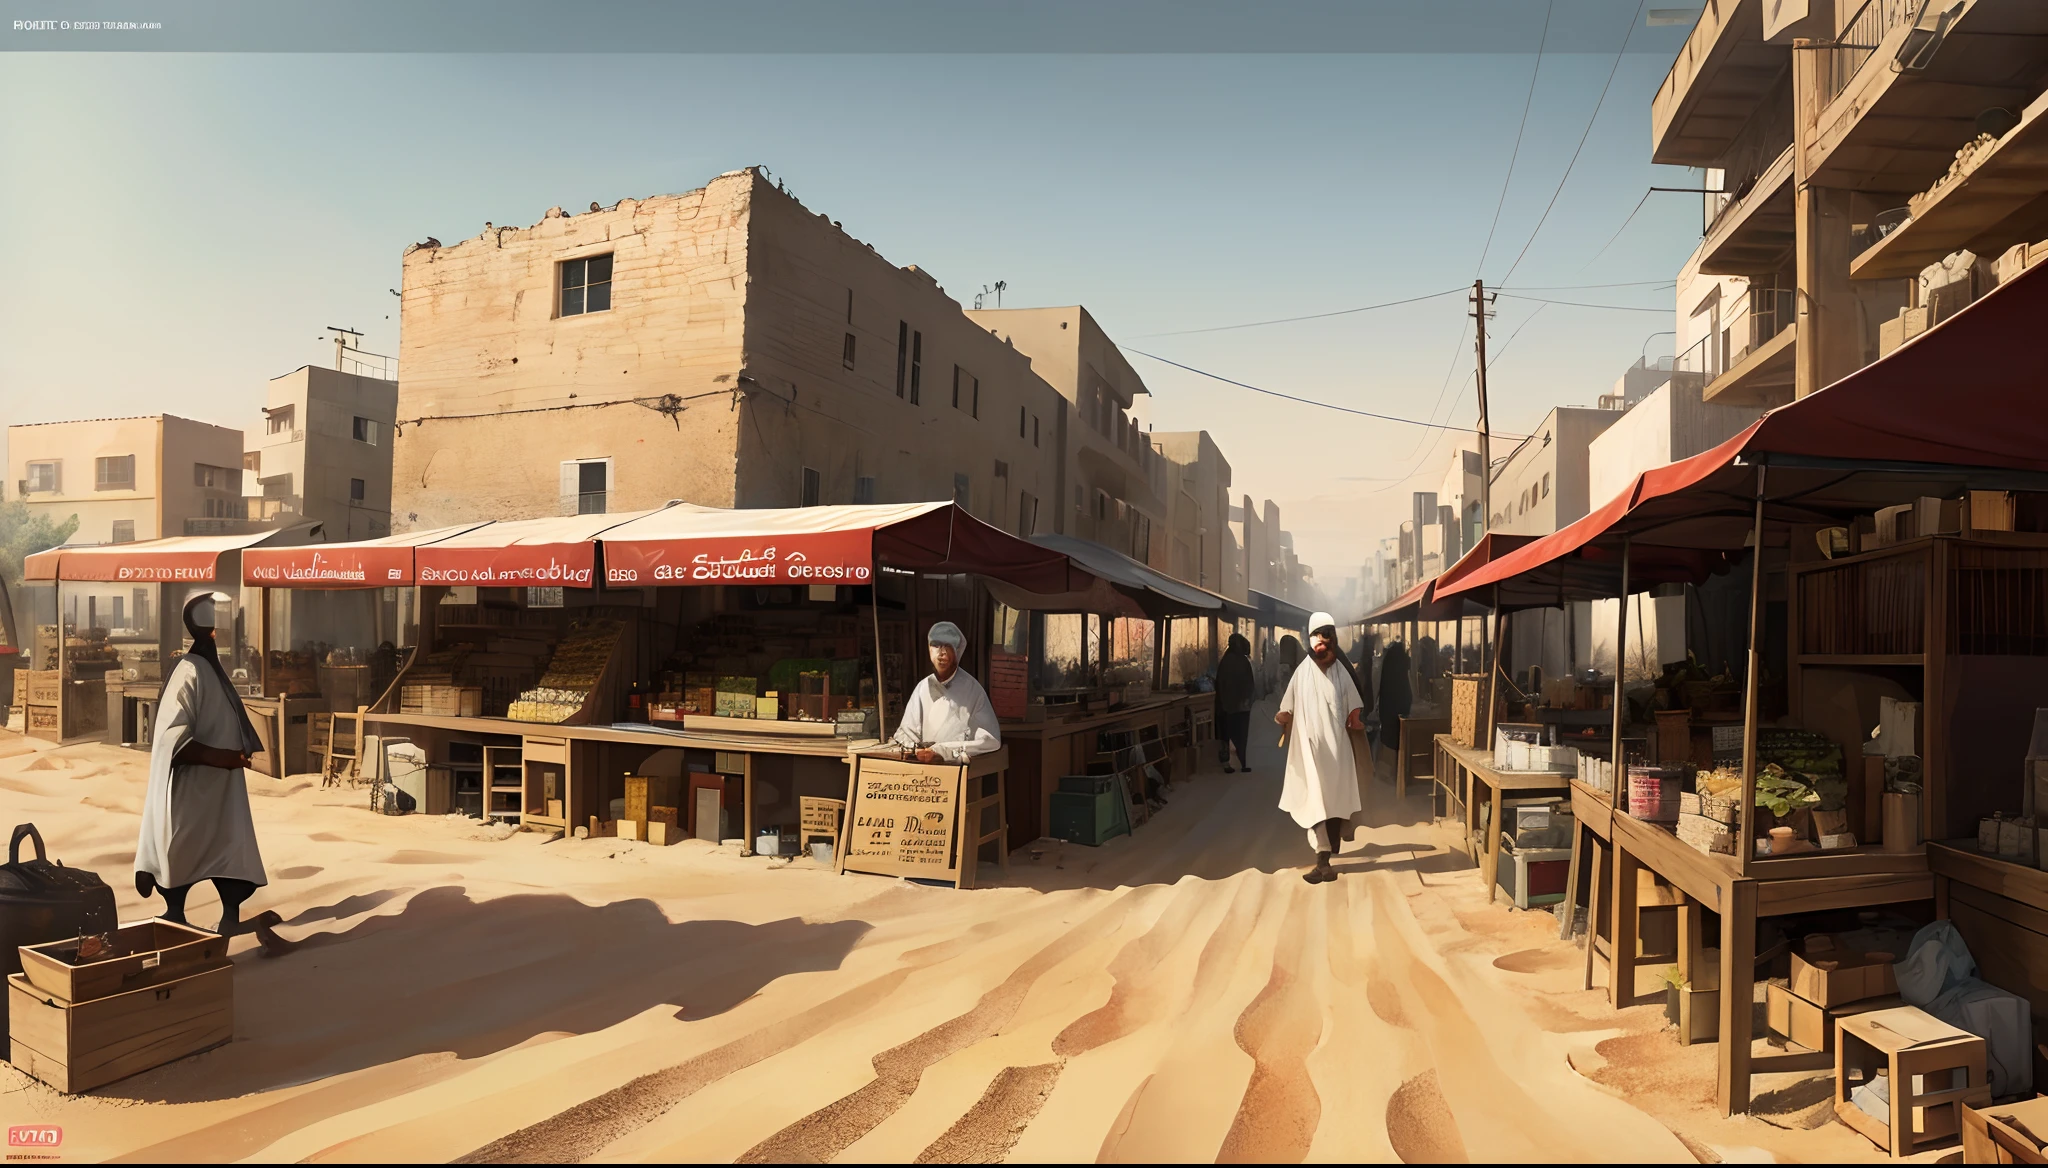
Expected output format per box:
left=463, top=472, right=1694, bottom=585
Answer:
left=598, top=502, right=1094, bottom=594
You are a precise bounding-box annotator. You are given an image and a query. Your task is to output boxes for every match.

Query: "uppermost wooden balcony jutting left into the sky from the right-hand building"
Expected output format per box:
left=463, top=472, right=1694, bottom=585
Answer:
left=1651, top=0, right=1790, bottom=166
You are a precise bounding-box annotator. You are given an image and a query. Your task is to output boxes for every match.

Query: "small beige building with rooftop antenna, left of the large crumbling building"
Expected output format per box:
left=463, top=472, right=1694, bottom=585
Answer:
left=242, top=365, right=399, bottom=541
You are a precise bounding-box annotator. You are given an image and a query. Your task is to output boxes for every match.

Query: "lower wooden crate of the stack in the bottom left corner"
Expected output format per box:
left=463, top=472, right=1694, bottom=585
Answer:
left=6, top=963, right=236, bottom=1094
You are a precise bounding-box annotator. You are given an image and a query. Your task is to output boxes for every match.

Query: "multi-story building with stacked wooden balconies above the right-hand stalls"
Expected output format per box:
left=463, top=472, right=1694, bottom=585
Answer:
left=1651, top=0, right=2048, bottom=406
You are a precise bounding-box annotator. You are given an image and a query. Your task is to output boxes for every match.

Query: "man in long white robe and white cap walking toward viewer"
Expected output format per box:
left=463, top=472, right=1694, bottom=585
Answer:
left=1274, top=613, right=1364, bottom=883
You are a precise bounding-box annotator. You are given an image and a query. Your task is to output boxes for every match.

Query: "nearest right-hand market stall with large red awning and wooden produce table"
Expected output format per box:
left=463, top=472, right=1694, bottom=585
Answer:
left=1438, top=257, right=2048, bottom=1111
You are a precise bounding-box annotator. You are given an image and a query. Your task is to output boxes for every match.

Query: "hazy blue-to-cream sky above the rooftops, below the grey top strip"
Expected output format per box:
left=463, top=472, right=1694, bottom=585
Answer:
left=0, top=0, right=1700, bottom=584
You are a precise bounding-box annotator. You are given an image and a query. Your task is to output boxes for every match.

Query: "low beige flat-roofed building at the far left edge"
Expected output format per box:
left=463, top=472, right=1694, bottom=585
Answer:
left=6, top=414, right=244, bottom=543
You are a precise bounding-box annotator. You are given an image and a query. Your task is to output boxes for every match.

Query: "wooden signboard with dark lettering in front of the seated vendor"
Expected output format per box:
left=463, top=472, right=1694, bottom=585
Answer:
left=842, top=758, right=961, bottom=883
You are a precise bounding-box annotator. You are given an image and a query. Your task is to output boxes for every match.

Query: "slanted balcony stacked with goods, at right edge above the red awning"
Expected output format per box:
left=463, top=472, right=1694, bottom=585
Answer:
left=1849, top=86, right=2048, bottom=279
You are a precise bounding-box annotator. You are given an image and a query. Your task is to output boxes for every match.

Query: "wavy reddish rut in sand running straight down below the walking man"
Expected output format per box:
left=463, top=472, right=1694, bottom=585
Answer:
left=1217, top=872, right=1343, bottom=1164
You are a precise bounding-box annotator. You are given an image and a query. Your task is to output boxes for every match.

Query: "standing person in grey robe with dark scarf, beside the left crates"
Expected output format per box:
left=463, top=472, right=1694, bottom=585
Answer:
left=135, top=592, right=283, bottom=951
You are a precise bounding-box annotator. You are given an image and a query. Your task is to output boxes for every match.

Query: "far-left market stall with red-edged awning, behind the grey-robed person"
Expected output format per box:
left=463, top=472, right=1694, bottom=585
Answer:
left=16, top=525, right=319, bottom=754
